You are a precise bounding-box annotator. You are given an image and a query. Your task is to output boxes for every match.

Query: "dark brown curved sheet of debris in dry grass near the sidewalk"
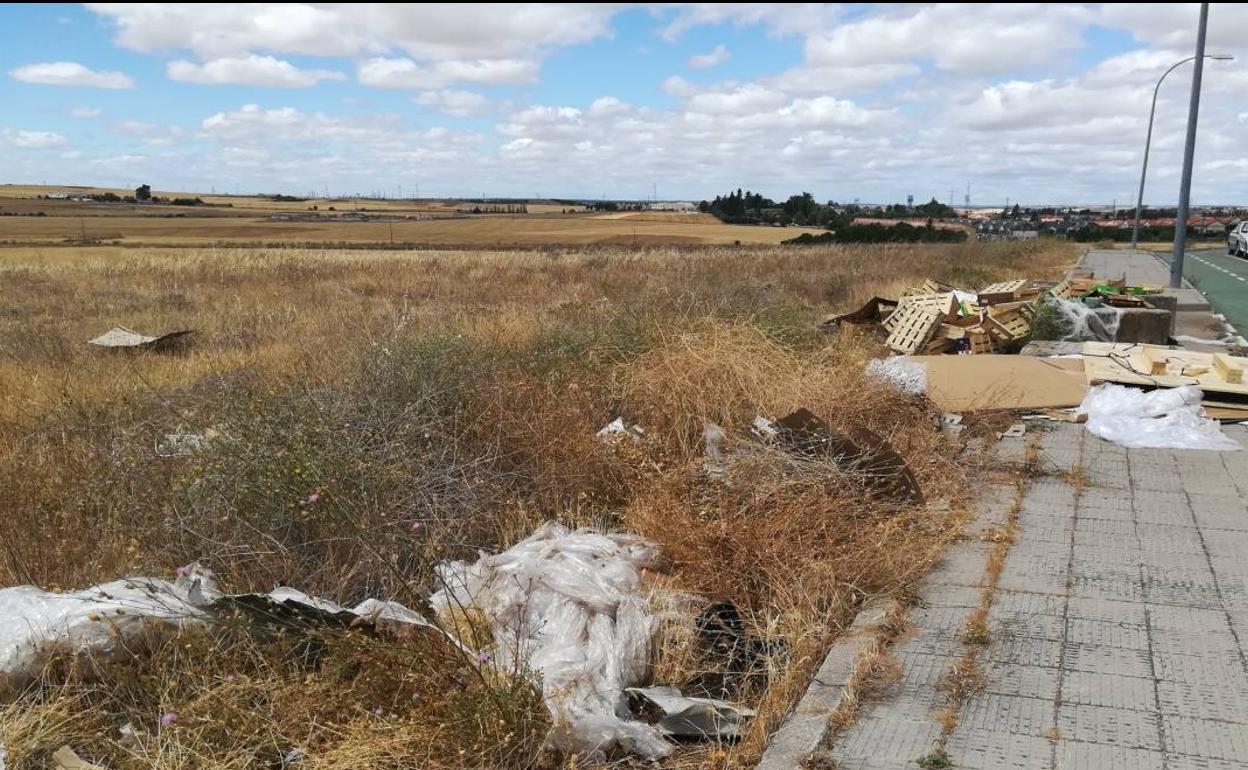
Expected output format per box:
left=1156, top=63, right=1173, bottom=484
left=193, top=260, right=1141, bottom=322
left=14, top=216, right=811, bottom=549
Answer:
left=775, top=408, right=924, bottom=503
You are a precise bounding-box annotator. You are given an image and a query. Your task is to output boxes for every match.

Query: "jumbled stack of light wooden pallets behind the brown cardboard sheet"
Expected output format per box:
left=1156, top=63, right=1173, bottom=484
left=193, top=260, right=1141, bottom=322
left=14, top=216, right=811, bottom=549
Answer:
left=873, top=280, right=1043, bottom=354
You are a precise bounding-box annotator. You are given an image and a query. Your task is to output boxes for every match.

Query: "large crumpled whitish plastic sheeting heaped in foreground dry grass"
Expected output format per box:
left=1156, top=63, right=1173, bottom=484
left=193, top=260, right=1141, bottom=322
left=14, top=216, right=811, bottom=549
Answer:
left=431, top=523, right=673, bottom=759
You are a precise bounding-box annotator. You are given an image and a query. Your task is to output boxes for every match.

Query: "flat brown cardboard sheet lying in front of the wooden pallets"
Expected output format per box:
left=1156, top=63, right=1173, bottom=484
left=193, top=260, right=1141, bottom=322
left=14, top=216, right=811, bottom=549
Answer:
left=912, top=354, right=1088, bottom=412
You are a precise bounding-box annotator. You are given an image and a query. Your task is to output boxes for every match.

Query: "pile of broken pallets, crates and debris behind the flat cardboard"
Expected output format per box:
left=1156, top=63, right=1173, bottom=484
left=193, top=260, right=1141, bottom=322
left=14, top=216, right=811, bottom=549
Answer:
left=822, top=277, right=1161, bottom=356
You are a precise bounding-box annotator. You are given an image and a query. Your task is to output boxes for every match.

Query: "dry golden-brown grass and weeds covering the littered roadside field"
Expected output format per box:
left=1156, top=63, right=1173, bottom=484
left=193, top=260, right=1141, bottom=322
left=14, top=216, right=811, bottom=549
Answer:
left=0, top=237, right=1071, bottom=769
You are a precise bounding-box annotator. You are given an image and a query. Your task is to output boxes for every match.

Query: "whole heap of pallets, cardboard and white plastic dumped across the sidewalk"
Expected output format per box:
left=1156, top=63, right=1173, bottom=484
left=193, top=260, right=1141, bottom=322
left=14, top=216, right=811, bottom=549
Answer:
left=822, top=277, right=1248, bottom=451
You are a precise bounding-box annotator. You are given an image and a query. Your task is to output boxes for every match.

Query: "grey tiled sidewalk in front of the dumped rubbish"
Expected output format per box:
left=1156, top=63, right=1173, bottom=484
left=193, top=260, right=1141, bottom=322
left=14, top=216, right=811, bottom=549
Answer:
left=831, top=426, right=1248, bottom=770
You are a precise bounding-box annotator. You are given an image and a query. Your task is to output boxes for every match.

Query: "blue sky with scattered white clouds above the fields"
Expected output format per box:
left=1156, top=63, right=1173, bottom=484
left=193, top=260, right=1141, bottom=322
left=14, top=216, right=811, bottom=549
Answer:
left=0, top=2, right=1248, bottom=206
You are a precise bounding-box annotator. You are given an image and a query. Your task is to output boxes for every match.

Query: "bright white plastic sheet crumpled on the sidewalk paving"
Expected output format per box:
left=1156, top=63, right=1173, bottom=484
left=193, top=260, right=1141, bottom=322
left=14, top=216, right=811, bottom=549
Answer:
left=1078, top=383, right=1239, bottom=452
